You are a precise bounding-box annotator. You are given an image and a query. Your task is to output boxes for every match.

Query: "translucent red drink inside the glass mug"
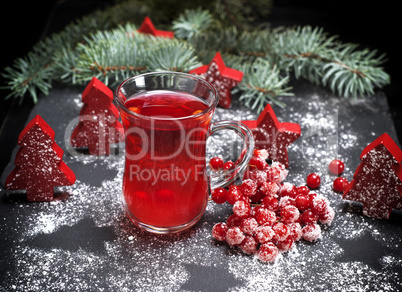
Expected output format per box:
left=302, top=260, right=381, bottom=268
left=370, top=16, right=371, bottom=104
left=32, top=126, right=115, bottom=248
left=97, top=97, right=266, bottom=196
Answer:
left=122, top=91, right=212, bottom=228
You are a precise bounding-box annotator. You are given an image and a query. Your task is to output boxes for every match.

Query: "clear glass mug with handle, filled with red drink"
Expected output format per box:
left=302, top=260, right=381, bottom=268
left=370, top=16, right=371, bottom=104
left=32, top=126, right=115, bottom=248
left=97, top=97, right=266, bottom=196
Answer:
left=114, top=72, right=254, bottom=234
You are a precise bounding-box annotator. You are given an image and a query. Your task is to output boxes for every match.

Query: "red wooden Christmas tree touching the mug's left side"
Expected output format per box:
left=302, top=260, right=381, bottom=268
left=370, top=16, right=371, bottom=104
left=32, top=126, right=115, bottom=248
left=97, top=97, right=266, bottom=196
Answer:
left=70, top=77, right=124, bottom=155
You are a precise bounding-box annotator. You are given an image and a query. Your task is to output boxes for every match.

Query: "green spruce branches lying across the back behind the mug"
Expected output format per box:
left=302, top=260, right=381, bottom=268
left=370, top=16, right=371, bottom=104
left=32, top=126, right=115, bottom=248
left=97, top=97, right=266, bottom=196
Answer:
left=3, top=0, right=390, bottom=111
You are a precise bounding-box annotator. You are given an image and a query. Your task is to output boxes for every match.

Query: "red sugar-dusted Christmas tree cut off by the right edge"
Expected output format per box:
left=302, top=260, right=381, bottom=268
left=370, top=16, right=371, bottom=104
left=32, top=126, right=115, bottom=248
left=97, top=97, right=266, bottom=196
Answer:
left=343, top=133, right=402, bottom=219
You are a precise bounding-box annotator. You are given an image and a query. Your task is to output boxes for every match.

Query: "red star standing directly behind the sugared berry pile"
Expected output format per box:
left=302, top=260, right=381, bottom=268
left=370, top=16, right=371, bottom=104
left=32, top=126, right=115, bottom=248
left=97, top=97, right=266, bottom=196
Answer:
left=242, top=104, right=301, bottom=168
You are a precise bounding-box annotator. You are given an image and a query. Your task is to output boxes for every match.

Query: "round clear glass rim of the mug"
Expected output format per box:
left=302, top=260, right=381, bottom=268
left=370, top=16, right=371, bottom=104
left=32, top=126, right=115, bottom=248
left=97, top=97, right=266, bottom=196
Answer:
left=114, top=71, right=219, bottom=121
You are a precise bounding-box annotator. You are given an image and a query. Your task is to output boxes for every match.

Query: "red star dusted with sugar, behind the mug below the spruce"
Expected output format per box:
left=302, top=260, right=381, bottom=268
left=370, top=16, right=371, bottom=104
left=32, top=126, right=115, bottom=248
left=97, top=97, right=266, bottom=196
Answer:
left=189, top=52, right=243, bottom=108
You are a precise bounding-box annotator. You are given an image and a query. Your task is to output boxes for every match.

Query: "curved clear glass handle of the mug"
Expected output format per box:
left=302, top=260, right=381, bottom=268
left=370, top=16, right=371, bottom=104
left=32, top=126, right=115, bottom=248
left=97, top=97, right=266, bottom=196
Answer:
left=208, top=120, right=254, bottom=191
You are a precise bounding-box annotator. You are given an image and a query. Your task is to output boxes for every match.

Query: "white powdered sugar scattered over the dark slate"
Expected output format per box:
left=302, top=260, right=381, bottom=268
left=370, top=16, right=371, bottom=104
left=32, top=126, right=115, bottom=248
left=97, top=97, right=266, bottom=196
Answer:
left=0, top=90, right=402, bottom=291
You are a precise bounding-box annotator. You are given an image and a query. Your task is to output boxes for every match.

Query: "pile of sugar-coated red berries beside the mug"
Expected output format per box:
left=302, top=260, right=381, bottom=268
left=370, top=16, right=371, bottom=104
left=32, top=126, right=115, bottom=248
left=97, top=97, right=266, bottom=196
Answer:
left=211, top=150, right=335, bottom=262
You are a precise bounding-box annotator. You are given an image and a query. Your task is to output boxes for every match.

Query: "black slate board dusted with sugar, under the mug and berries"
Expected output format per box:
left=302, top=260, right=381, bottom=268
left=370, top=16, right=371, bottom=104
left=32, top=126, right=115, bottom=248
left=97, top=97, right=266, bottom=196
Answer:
left=0, top=81, right=402, bottom=291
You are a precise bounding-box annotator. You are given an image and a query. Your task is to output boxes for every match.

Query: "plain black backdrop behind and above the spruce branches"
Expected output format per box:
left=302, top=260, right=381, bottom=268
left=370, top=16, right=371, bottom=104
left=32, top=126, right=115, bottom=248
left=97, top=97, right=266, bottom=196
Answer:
left=0, top=0, right=402, bottom=170
